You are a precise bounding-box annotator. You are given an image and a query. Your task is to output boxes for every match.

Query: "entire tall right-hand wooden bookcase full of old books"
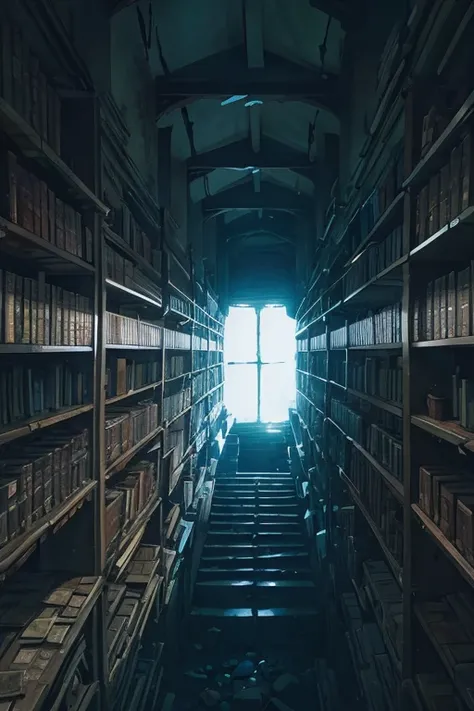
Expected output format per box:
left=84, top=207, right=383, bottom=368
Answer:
left=296, top=3, right=474, bottom=709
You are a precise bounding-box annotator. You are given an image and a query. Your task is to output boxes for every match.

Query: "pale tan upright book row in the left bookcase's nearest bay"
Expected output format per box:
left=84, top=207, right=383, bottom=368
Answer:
left=0, top=269, right=93, bottom=346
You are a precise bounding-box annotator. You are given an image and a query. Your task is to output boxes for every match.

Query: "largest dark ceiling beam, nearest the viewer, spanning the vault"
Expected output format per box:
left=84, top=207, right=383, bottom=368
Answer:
left=155, top=52, right=339, bottom=117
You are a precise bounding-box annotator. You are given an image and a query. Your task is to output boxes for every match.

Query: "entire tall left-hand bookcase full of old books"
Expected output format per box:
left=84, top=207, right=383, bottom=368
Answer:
left=0, top=8, right=227, bottom=711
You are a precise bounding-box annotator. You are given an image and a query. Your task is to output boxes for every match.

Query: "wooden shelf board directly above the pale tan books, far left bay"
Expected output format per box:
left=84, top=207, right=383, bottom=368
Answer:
left=0, top=217, right=95, bottom=275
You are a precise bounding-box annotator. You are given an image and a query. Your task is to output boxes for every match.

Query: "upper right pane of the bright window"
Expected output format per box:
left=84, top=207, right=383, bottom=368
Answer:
left=260, top=306, right=296, bottom=364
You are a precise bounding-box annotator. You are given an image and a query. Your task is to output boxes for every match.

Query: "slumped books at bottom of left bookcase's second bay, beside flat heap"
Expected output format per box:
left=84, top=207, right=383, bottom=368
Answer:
left=106, top=543, right=163, bottom=700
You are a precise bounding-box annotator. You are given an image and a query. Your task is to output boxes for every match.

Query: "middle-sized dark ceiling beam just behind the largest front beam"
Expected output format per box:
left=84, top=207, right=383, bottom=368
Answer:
left=187, top=139, right=315, bottom=173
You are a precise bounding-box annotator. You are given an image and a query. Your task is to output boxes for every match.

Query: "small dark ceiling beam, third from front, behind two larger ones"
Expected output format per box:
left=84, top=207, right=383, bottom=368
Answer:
left=201, top=183, right=312, bottom=212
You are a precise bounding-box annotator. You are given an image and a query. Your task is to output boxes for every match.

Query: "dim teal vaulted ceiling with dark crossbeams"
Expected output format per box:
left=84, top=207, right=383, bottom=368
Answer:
left=112, top=0, right=347, bottom=304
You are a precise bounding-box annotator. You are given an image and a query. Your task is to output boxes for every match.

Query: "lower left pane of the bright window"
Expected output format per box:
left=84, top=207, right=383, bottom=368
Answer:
left=224, top=365, right=257, bottom=422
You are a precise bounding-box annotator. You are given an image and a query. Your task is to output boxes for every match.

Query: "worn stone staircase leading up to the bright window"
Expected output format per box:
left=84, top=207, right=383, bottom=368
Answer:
left=191, top=424, right=318, bottom=641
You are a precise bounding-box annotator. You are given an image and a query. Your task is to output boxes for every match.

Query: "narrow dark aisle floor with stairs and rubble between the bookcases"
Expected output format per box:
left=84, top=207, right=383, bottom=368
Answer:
left=167, top=424, right=334, bottom=711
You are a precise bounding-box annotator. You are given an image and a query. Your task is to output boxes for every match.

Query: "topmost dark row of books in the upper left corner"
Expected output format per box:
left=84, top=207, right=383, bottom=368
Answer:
left=0, top=18, right=61, bottom=155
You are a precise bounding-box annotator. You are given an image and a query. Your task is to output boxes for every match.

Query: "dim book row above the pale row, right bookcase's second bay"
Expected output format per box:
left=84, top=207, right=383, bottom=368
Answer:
left=344, top=225, right=403, bottom=297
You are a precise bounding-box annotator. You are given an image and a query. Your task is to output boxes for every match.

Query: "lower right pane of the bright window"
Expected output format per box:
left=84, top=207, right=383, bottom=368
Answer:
left=260, top=362, right=295, bottom=422
